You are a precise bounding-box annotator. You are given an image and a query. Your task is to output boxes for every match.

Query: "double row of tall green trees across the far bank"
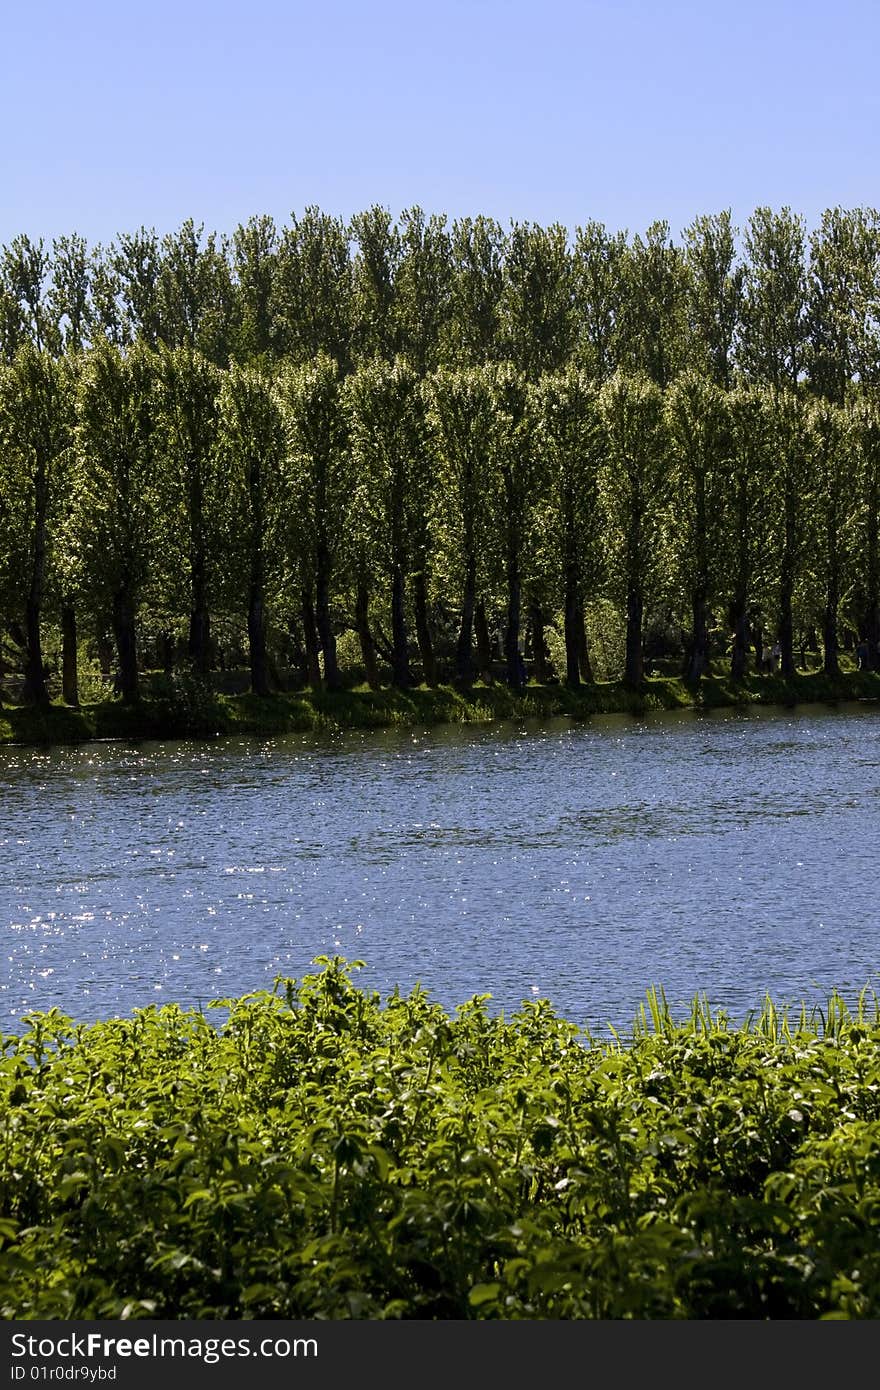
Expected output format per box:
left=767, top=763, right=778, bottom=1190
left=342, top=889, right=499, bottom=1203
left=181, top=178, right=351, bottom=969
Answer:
left=0, top=207, right=880, bottom=703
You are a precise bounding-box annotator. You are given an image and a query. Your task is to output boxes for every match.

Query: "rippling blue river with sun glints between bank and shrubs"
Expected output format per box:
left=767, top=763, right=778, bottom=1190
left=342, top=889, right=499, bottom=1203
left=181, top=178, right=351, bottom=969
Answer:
left=0, top=705, right=880, bottom=1036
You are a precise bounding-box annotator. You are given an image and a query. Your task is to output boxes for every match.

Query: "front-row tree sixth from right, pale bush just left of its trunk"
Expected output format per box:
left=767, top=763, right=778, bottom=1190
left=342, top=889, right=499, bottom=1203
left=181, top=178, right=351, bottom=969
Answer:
left=599, top=371, right=669, bottom=685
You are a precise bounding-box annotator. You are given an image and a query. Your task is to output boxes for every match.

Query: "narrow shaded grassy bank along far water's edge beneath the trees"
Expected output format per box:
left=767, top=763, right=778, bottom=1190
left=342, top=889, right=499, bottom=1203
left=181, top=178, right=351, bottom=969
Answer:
left=0, top=671, right=880, bottom=744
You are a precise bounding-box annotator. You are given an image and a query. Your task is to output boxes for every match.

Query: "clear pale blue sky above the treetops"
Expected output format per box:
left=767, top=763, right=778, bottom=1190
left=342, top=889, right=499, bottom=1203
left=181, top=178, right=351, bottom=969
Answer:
left=0, top=0, right=880, bottom=242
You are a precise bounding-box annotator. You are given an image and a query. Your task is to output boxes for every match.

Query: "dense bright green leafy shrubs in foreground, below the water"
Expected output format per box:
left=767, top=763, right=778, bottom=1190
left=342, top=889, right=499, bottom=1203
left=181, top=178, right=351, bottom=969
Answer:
left=0, top=959, right=880, bottom=1319
